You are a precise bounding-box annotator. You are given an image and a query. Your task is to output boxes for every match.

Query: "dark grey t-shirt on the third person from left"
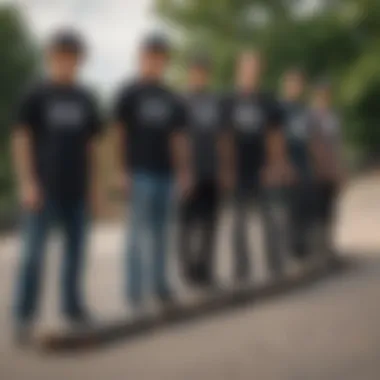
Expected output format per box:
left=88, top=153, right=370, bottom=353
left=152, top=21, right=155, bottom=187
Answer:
left=186, top=91, right=224, bottom=180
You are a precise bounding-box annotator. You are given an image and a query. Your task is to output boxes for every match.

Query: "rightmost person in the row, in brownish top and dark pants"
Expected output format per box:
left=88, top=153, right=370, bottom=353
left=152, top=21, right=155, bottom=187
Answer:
left=309, top=79, right=345, bottom=256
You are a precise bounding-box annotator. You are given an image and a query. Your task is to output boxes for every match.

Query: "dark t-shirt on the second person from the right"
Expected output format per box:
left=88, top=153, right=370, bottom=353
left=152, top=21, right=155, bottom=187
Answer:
left=282, top=101, right=311, bottom=174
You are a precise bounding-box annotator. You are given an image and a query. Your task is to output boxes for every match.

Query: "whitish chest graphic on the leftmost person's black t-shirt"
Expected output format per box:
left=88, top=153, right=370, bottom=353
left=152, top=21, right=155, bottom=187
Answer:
left=47, top=101, right=85, bottom=129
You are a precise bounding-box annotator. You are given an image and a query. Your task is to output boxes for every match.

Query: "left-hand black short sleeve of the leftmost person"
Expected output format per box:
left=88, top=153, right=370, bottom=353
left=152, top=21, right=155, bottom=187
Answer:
left=13, top=89, right=40, bottom=129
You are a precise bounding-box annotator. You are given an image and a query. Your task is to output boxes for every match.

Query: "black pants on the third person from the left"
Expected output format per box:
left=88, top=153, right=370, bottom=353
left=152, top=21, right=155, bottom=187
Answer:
left=179, top=179, right=219, bottom=282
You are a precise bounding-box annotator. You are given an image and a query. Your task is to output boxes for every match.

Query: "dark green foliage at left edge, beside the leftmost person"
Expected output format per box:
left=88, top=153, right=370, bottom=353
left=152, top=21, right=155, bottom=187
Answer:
left=0, top=6, right=37, bottom=211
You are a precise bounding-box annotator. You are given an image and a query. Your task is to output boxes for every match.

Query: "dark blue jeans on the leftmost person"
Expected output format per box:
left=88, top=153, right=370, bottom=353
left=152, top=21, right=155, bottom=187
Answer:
left=15, top=200, right=86, bottom=322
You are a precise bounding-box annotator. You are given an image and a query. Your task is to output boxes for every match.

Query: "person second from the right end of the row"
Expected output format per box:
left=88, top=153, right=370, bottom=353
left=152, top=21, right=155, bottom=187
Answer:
left=281, top=68, right=314, bottom=260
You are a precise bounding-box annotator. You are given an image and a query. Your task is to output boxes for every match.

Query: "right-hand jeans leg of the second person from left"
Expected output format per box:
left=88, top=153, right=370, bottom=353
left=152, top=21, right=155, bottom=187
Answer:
left=150, top=178, right=172, bottom=299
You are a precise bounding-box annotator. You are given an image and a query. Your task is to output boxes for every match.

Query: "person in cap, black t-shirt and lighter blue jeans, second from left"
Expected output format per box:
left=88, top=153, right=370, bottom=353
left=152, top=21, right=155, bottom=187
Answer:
left=114, top=34, right=192, bottom=314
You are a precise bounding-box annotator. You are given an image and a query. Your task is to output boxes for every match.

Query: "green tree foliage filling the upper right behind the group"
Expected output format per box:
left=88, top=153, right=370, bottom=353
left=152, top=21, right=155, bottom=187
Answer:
left=156, top=0, right=380, bottom=153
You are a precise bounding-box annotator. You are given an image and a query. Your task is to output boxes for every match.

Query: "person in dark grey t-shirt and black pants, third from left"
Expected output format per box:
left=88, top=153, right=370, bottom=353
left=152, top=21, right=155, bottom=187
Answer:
left=179, top=53, right=229, bottom=286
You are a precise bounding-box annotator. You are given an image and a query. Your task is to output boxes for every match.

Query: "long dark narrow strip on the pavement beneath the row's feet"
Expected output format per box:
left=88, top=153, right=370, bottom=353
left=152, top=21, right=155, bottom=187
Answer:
left=38, top=252, right=352, bottom=353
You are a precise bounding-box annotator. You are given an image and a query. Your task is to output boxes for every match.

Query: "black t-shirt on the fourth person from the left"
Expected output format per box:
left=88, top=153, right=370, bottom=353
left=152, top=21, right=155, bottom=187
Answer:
left=223, top=93, right=283, bottom=180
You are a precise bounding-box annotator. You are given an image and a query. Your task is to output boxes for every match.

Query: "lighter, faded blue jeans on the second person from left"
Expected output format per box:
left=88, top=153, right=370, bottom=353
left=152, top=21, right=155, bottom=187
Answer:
left=126, top=172, right=172, bottom=304
